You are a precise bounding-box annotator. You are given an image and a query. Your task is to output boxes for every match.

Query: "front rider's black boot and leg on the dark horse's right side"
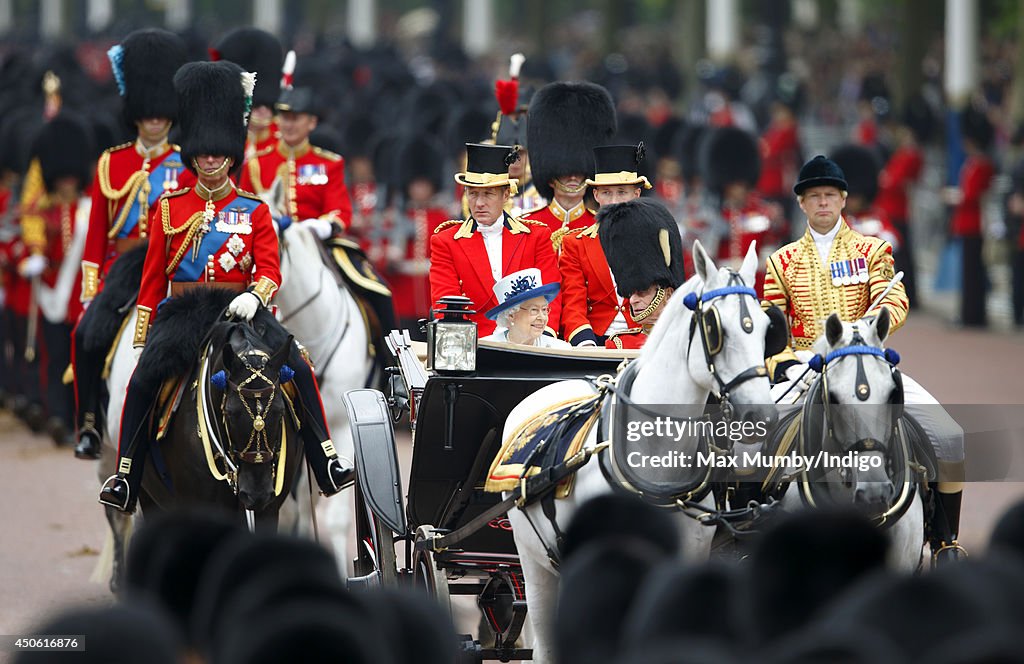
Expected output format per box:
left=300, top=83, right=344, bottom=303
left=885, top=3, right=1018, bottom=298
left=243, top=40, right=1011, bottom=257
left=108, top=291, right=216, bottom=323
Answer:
left=289, top=348, right=355, bottom=496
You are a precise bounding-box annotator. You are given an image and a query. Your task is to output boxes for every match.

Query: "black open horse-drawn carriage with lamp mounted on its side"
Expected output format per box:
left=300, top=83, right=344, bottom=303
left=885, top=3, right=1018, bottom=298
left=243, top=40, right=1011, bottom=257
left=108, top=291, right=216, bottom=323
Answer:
left=345, top=332, right=636, bottom=661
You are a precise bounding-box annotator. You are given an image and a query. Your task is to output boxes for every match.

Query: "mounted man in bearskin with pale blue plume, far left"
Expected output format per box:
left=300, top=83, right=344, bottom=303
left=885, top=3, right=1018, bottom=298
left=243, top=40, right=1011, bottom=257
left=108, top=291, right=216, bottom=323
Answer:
left=72, top=30, right=195, bottom=459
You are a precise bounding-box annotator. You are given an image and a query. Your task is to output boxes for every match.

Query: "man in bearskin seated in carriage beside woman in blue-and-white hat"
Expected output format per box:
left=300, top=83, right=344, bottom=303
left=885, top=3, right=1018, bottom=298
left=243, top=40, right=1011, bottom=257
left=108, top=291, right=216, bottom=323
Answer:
left=597, top=199, right=686, bottom=349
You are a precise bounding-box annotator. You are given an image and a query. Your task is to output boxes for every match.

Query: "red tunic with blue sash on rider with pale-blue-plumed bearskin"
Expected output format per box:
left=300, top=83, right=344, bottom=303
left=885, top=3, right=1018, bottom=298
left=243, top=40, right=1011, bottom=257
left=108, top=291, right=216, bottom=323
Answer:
left=82, top=141, right=196, bottom=301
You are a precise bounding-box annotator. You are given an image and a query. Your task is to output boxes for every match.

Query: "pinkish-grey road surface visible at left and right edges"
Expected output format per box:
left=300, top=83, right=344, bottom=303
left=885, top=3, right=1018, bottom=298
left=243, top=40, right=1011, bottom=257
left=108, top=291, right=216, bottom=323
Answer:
left=0, top=315, right=1024, bottom=647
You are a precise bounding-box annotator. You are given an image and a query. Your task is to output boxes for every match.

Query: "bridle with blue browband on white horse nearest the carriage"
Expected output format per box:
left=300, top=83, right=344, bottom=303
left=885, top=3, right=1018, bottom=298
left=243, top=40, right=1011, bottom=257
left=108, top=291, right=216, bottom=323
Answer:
left=683, top=269, right=768, bottom=419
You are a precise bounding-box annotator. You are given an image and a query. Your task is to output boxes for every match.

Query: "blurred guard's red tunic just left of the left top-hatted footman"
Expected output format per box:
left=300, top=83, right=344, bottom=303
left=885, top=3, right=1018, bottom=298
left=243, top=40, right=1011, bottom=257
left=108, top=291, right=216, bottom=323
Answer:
left=383, top=208, right=446, bottom=320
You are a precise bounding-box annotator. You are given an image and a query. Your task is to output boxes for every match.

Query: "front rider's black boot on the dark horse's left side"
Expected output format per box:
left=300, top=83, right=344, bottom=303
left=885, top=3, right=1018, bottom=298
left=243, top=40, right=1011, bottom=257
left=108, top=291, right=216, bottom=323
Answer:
left=99, top=377, right=157, bottom=514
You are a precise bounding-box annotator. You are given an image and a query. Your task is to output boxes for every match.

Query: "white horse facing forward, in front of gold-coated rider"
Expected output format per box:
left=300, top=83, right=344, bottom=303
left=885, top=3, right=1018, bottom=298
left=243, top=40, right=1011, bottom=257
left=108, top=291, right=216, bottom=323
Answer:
left=781, top=307, right=925, bottom=572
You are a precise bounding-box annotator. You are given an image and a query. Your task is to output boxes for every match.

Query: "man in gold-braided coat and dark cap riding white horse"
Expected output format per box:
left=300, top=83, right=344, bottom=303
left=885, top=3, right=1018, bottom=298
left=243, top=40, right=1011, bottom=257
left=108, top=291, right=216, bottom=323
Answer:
left=762, top=155, right=964, bottom=558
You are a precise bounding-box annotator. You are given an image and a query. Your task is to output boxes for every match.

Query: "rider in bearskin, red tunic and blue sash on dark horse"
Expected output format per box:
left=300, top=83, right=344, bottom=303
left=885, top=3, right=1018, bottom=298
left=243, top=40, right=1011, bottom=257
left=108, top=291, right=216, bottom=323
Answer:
left=99, top=61, right=352, bottom=512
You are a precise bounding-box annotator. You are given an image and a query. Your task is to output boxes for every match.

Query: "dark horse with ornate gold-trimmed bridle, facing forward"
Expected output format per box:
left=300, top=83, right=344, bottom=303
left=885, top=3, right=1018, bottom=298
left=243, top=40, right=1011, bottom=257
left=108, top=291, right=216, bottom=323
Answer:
left=139, top=293, right=303, bottom=530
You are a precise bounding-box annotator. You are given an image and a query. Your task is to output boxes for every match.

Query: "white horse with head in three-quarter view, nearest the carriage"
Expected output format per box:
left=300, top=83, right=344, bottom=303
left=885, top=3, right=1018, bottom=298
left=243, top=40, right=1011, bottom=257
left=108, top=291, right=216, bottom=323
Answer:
left=505, top=242, right=775, bottom=663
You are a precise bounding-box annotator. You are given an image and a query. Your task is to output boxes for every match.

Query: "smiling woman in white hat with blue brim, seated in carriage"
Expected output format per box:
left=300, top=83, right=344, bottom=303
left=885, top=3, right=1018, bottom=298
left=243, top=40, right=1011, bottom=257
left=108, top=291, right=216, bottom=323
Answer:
left=481, top=267, right=571, bottom=348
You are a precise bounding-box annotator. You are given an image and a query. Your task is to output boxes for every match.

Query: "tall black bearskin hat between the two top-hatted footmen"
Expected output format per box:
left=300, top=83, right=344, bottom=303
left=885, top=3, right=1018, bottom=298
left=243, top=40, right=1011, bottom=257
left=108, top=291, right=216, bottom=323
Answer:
left=526, top=82, right=615, bottom=201
